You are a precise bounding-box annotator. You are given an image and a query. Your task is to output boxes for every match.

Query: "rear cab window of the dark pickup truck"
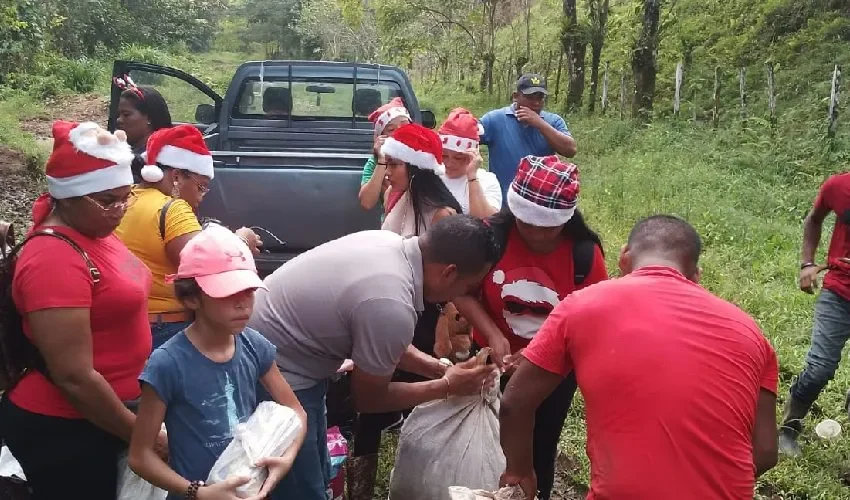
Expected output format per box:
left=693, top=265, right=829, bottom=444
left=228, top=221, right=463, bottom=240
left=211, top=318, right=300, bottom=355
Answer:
left=232, top=79, right=401, bottom=121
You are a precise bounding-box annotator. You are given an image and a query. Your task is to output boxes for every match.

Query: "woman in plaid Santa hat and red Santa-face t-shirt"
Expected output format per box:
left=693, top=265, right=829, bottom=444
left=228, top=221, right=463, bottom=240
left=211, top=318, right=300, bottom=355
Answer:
left=454, top=156, right=608, bottom=500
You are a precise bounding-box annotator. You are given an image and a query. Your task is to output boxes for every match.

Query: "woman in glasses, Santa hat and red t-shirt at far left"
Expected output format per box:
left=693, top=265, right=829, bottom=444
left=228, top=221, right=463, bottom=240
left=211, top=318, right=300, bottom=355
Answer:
left=0, top=121, right=167, bottom=500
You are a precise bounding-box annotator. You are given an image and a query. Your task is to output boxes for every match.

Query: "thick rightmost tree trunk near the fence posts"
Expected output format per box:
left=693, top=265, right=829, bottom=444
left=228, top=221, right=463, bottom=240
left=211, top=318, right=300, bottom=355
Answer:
left=632, top=0, right=661, bottom=121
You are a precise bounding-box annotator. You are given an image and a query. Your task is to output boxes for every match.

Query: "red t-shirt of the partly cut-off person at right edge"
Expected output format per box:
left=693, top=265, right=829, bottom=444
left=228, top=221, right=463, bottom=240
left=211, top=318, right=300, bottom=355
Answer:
left=815, top=173, right=850, bottom=300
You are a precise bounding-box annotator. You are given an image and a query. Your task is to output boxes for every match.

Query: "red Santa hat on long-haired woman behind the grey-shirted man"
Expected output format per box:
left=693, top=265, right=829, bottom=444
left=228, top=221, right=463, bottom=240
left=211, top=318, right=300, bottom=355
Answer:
left=381, top=123, right=445, bottom=175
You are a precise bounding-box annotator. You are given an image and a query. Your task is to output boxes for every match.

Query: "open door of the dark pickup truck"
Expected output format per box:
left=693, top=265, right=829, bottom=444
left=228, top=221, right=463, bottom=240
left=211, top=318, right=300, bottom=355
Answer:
left=108, top=61, right=222, bottom=145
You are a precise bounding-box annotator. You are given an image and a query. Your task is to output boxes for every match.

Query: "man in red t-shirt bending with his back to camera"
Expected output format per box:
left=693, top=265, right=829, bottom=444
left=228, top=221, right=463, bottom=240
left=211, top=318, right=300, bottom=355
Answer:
left=501, top=215, right=778, bottom=500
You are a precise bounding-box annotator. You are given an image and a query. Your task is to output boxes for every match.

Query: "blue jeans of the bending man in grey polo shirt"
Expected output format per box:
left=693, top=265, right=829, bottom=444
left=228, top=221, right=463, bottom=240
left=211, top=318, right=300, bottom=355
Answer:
left=264, top=382, right=331, bottom=500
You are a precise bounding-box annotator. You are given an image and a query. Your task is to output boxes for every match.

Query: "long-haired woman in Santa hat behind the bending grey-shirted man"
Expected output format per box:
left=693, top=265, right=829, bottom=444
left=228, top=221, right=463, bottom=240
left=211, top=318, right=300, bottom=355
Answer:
left=347, top=124, right=461, bottom=500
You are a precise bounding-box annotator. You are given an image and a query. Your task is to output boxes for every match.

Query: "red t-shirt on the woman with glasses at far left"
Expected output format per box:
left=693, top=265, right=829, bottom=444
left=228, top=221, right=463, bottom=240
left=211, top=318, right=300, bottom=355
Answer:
left=9, top=227, right=151, bottom=418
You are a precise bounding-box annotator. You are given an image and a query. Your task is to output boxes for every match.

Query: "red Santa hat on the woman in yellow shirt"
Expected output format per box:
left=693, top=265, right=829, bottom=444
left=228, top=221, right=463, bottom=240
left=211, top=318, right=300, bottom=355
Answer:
left=142, top=125, right=213, bottom=182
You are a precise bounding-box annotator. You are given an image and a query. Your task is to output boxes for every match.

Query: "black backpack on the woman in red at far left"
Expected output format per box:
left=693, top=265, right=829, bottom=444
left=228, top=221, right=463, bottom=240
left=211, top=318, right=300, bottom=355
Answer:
left=0, top=228, right=100, bottom=391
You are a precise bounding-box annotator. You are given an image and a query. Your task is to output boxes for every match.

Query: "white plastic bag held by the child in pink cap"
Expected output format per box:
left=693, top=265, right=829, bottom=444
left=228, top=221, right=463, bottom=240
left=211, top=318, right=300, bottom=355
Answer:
left=207, top=401, right=301, bottom=498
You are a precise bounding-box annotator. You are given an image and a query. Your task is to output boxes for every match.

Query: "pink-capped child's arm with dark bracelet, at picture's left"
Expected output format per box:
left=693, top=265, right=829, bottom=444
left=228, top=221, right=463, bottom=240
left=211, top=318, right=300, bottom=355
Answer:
left=128, top=383, right=250, bottom=500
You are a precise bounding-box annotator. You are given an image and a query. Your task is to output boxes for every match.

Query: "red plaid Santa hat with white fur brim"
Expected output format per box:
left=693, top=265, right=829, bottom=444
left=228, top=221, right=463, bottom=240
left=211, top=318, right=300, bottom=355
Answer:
left=508, top=155, right=579, bottom=227
